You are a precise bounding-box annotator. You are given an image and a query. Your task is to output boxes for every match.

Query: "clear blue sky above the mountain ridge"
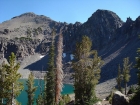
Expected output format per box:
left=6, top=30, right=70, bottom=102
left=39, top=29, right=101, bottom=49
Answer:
left=0, top=0, right=140, bottom=23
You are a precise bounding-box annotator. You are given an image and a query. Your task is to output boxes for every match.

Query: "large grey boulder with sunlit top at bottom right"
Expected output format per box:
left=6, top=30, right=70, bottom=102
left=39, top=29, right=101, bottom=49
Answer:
left=112, top=91, right=129, bottom=105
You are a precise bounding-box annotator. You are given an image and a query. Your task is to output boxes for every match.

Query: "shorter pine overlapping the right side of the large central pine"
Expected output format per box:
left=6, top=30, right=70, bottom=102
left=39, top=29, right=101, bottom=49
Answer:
left=85, top=51, right=103, bottom=105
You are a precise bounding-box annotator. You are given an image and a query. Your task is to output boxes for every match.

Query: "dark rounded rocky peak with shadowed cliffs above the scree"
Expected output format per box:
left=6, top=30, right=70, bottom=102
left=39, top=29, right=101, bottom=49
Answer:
left=64, top=10, right=123, bottom=51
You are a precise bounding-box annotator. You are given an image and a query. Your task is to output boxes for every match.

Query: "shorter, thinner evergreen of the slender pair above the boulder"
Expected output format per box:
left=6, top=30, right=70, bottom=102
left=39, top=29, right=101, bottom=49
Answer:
left=116, top=65, right=122, bottom=92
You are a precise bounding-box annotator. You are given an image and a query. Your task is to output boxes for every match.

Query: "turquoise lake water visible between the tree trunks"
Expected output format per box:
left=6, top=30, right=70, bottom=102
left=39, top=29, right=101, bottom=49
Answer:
left=17, top=79, right=73, bottom=105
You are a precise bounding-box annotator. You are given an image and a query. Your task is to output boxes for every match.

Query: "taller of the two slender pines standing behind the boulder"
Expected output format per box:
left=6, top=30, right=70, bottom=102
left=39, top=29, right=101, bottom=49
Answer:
left=123, top=57, right=131, bottom=95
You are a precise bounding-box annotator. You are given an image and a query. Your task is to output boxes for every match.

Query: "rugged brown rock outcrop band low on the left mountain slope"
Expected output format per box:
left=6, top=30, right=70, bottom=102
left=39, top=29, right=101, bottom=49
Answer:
left=0, top=37, right=41, bottom=59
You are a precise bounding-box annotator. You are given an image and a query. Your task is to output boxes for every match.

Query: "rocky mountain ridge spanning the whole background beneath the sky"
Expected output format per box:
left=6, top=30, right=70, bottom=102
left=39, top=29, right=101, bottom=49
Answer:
left=0, top=10, right=140, bottom=84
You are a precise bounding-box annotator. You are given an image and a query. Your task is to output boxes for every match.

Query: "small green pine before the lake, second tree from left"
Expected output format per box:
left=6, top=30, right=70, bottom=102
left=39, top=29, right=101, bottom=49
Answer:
left=26, top=72, right=37, bottom=105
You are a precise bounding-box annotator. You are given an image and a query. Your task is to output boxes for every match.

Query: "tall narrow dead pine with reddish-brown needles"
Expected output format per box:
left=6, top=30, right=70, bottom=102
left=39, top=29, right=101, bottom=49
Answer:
left=55, top=31, right=63, bottom=105
